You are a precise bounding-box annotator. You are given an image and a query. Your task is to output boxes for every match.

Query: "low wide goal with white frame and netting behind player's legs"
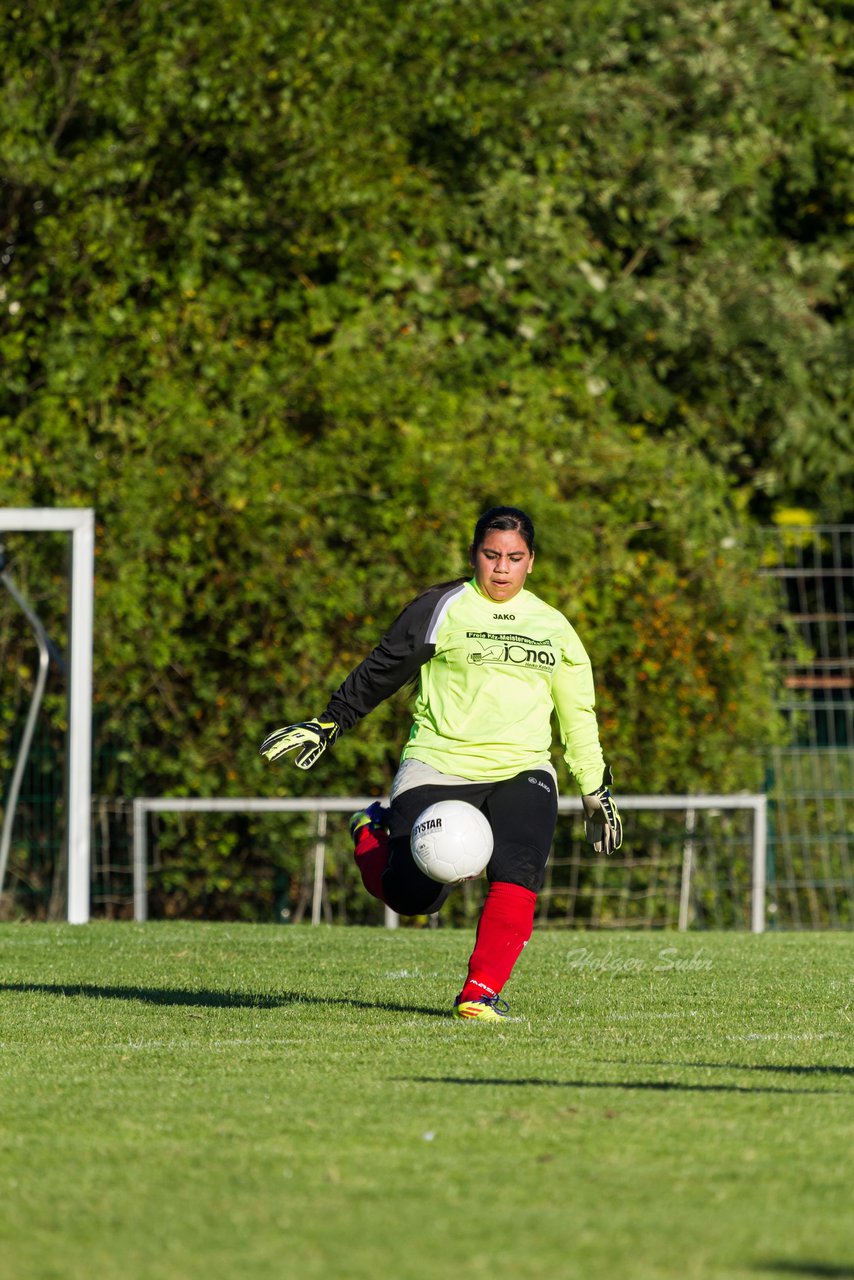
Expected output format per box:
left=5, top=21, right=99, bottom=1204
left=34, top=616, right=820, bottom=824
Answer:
left=133, top=795, right=766, bottom=932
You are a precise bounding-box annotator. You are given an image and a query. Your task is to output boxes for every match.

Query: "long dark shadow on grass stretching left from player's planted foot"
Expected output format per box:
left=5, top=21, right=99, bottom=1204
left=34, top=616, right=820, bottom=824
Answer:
left=0, top=982, right=448, bottom=1018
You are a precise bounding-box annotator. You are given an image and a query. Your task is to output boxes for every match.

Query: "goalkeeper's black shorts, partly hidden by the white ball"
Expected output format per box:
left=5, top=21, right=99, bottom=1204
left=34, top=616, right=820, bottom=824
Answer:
left=383, top=769, right=557, bottom=915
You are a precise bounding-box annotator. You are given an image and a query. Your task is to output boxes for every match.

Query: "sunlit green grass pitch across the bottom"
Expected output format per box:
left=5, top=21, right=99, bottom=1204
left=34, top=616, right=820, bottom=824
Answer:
left=0, top=924, right=854, bottom=1280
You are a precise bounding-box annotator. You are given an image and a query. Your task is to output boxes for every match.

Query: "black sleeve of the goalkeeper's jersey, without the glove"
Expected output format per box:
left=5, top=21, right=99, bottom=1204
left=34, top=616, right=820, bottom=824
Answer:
left=324, top=584, right=458, bottom=733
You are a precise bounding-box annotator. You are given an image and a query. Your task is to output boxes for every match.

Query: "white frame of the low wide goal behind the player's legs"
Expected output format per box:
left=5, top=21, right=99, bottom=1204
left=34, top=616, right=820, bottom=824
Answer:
left=133, top=792, right=768, bottom=933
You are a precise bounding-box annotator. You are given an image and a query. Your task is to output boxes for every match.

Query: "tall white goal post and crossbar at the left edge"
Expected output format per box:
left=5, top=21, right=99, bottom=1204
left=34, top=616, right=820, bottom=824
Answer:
left=0, top=507, right=95, bottom=924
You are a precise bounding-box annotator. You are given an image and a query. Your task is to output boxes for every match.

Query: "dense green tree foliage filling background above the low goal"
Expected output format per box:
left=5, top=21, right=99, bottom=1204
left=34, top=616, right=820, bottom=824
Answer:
left=0, top=0, right=853, bottom=921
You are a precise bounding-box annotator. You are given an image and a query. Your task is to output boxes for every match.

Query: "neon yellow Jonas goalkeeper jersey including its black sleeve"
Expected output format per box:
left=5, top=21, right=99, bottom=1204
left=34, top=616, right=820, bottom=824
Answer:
left=326, top=581, right=604, bottom=794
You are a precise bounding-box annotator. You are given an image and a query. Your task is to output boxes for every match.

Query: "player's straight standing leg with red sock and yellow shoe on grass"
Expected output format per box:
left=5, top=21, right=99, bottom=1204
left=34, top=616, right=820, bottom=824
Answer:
left=455, top=771, right=557, bottom=1020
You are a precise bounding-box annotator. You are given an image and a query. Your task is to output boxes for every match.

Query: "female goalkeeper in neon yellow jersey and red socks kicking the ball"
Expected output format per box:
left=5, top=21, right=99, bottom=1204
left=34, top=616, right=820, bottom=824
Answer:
left=261, top=507, right=622, bottom=1020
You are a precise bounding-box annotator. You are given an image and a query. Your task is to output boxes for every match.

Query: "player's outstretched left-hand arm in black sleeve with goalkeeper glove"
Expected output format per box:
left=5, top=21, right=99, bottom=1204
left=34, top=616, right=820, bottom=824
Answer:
left=261, top=593, right=435, bottom=769
